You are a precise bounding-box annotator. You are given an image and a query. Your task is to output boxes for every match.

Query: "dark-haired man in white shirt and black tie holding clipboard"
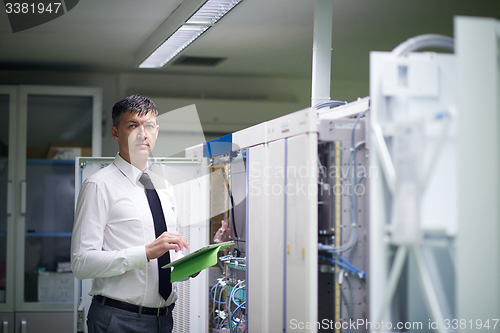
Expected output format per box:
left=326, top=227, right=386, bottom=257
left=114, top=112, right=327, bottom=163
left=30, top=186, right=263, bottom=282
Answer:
left=71, top=95, right=189, bottom=333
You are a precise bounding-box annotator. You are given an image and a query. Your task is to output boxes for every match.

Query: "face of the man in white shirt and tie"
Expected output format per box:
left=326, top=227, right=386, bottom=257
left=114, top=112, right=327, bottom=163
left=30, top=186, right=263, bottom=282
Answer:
left=111, top=111, right=159, bottom=164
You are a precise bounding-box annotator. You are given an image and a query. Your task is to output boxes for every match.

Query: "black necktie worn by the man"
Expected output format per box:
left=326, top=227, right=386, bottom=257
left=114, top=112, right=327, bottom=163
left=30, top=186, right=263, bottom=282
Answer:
left=139, top=173, right=172, bottom=300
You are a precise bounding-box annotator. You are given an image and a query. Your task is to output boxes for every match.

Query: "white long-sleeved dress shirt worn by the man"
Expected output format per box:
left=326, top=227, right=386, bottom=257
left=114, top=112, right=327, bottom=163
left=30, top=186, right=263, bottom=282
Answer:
left=71, top=154, right=180, bottom=308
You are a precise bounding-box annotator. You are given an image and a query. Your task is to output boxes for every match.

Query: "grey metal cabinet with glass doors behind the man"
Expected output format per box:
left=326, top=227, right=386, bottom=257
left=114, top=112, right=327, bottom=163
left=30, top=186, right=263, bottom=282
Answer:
left=0, top=86, right=101, bottom=333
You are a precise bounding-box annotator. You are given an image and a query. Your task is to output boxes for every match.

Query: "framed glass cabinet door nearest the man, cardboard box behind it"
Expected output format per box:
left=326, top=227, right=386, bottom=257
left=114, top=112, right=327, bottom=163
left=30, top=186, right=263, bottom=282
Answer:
left=16, top=86, right=101, bottom=312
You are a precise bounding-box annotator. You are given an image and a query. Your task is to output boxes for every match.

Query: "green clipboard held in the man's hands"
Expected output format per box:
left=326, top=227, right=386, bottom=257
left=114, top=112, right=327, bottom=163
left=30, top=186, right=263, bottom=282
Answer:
left=162, top=241, right=234, bottom=282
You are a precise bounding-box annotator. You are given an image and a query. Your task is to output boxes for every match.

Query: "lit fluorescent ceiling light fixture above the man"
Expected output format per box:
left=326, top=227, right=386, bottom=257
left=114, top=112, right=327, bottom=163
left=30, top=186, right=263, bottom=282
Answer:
left=139, top=0, right=243, bottom=68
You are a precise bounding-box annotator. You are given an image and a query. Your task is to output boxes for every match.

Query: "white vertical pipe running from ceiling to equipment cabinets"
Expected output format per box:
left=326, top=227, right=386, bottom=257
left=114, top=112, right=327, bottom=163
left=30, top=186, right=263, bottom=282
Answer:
left=311, top=0, right=333, bottom=107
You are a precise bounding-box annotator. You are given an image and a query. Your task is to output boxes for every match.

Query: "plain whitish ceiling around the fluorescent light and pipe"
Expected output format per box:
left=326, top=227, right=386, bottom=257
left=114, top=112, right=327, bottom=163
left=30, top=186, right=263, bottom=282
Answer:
left=0, top=0, right=500, bottom=80
